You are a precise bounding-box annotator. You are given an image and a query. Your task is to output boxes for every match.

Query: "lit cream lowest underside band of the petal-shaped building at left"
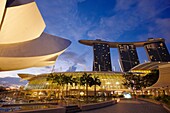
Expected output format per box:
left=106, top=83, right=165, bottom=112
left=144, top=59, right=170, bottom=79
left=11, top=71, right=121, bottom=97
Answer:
left=0, top=53, right=58, bottom=71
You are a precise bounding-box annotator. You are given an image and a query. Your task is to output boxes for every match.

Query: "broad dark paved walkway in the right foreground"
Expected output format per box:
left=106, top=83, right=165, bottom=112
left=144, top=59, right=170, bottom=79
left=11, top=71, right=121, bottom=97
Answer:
left=78, top=100, right=169, bottom=113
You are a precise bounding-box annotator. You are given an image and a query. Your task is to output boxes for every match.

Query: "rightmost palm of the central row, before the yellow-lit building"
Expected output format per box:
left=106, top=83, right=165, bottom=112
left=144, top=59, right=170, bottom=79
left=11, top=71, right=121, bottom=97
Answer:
left=89, top=76, right=101, bottom=99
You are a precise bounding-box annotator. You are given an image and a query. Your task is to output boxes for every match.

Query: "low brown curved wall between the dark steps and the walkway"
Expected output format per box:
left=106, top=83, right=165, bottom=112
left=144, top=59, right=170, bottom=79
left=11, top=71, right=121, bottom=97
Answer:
left=80, top=100, right=117, bottom=111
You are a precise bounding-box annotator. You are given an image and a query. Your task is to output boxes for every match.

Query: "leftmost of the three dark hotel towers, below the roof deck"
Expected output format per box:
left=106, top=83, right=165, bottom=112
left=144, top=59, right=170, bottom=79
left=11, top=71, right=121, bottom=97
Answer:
left=93, top=43, right=112, bottom=71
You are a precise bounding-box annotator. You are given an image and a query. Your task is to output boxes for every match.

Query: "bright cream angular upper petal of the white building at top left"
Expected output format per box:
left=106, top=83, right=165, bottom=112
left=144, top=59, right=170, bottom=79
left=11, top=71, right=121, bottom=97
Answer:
left=0, top=2, right=45, bottom=44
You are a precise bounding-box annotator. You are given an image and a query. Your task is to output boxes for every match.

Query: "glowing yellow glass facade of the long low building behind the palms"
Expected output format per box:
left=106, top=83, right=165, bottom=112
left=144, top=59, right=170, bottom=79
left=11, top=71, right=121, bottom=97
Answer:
left=25, top=72, right=126, bottom=91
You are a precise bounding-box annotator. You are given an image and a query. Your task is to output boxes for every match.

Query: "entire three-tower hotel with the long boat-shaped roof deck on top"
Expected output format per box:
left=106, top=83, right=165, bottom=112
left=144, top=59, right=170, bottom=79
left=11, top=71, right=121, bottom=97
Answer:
left=79, top=38, right=170, bottom=72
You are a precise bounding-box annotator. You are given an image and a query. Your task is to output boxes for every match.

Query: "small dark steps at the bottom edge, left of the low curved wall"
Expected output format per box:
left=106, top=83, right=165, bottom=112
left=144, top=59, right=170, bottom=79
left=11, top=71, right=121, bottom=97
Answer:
left=66, top=105, right=81, bottom=113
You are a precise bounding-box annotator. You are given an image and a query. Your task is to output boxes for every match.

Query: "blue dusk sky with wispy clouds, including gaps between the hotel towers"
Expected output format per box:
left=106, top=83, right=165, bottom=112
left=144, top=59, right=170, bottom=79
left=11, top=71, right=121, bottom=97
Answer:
left=1, top=0, right=170, bottom=77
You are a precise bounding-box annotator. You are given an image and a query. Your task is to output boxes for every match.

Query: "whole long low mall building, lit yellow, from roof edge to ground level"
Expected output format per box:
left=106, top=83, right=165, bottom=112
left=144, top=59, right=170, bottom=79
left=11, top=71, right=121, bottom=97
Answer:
left=19, top=71, right=128, bottom=96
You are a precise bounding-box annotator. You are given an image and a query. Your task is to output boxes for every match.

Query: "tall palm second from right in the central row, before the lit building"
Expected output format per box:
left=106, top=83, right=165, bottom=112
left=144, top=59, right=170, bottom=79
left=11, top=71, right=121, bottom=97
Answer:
left=80, top=73, right=93, bottom=101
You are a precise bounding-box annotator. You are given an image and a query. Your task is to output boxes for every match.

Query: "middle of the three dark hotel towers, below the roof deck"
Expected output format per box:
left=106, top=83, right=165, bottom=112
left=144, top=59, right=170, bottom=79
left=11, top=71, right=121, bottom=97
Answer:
left=118, top=44, right=139, bottom=72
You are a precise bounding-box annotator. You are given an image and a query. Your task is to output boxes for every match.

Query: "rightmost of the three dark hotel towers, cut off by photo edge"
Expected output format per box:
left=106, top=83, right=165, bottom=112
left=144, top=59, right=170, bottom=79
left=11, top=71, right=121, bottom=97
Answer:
left=144, top=38, right=170, bottom=62
